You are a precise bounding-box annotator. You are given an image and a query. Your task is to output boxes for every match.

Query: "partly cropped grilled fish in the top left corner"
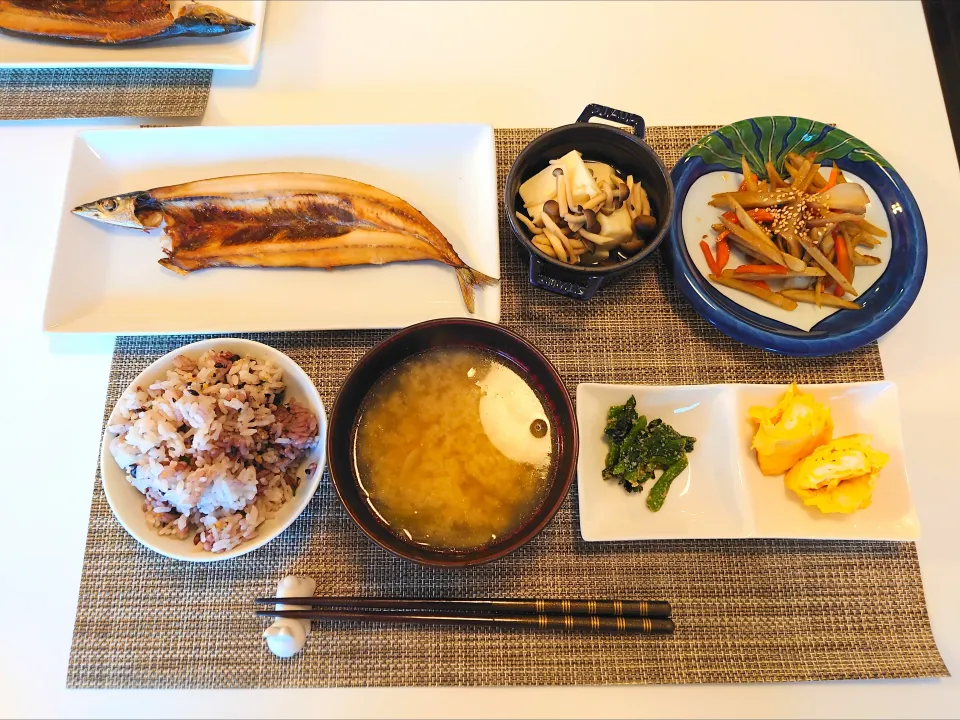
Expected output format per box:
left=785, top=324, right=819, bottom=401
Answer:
left=0, top=0, right=254, bottom=45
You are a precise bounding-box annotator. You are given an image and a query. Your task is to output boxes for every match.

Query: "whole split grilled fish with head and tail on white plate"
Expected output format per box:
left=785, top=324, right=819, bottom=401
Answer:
left=73, top=173, right=497, bottom=312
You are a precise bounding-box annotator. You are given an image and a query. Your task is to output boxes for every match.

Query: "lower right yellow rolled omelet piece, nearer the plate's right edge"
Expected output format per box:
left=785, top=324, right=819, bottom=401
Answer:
left=784, top=435, right=890, bottom=513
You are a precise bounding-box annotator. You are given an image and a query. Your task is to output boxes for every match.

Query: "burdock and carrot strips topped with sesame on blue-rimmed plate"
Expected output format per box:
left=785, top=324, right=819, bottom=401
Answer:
left=700, top=152, right=887, bottom=311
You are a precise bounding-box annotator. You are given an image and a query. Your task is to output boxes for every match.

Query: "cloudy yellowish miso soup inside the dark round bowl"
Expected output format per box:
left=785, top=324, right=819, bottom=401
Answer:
left=354, top=347, right=556, bottom=550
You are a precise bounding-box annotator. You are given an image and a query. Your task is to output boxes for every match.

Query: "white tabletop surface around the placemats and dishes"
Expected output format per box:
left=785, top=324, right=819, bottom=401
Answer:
left=0, top=0, right=960, bottom=717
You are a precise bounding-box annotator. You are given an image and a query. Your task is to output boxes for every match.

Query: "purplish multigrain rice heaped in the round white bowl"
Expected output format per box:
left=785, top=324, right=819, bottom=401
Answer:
left=107, top=350, right=319, bottom=552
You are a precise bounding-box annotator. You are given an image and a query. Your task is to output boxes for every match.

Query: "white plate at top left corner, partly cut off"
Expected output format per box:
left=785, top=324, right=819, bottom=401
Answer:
left=0, top=0, right=267, bottom=70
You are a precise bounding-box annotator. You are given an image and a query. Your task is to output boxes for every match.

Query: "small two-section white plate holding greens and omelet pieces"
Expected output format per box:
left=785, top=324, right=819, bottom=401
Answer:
left=577, top=382, right=920, bottom=541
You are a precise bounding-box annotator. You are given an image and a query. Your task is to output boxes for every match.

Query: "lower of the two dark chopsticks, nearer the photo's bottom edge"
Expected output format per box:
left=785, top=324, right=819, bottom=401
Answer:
left=257, top=598, right=674, bottom=635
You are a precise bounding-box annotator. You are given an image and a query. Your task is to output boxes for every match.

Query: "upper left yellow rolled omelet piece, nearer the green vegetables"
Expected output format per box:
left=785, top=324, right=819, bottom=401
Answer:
left=750, top=383, right=833, bottom=475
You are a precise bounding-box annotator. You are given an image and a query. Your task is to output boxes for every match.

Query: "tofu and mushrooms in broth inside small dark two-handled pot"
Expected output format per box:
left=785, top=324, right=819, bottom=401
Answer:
left=517, top=150, right=657, bottom=265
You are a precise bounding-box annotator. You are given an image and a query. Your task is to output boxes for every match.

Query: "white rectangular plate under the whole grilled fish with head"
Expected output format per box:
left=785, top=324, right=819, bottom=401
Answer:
left=44, top=125, right=500, bottom=334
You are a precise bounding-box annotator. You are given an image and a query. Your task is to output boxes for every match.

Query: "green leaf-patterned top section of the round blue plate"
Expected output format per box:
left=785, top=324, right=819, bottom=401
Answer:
left=686, top=115, right=890, bottom=177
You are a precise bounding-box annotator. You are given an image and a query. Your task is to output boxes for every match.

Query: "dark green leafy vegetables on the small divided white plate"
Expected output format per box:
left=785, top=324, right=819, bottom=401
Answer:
left=603, top=395, right=697, bottom=512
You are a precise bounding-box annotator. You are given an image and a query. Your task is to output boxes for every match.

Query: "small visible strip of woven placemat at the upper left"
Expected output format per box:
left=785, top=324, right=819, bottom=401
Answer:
left=0, top=68, right=213, bottom=120
